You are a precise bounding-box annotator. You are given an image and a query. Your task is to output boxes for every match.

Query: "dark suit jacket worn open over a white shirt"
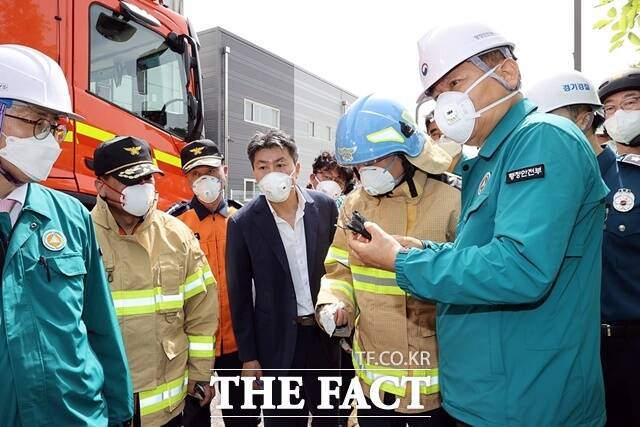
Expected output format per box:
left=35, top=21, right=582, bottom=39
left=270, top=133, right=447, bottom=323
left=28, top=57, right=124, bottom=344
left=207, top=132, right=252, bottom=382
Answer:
left=226, top=188, right=338, bottom=375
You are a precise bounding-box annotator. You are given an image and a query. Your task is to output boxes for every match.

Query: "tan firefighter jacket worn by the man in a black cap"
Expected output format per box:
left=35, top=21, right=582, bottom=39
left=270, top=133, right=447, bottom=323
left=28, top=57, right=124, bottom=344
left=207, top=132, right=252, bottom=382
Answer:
left=91, top=198, right=218, bottom=426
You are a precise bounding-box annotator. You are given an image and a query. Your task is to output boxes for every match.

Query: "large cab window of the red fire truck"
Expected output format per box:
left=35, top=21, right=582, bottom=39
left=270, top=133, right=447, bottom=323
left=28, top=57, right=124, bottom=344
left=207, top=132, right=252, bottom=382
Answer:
left=89, top=4, right=194, bottom=140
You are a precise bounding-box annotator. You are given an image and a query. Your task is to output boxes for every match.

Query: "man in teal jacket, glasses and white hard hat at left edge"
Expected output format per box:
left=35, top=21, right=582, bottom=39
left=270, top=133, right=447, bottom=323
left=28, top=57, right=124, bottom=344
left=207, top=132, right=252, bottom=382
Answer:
left=0, top=45, right=133, bottom=426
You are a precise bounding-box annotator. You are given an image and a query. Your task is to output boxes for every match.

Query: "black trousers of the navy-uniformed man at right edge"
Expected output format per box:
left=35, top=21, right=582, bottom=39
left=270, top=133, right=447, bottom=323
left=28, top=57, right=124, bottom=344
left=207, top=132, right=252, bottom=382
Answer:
left=600, top=334, right=640, bottom=427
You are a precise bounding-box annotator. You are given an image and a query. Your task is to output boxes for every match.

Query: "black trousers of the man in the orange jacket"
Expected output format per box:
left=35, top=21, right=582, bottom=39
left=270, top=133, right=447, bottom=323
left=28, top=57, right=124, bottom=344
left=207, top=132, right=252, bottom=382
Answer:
left=182, top=352, right=260, bottom=427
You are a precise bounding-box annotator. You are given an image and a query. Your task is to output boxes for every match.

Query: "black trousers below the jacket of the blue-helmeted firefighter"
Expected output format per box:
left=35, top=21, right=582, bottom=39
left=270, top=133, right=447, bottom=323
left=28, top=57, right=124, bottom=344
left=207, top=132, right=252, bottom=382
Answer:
left=358, top=393, right=456, bottom=427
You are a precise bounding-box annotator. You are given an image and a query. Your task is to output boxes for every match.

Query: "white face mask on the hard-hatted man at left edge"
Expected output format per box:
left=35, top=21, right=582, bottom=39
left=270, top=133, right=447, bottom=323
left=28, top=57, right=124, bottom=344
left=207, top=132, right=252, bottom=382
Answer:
left=0, top=134, right=62, bottom=182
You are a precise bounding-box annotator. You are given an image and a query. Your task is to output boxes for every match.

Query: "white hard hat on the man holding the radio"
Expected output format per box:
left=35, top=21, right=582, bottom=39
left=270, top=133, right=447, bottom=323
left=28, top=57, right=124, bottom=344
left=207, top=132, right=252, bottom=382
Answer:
left=418, top=23, right=515, bottom=103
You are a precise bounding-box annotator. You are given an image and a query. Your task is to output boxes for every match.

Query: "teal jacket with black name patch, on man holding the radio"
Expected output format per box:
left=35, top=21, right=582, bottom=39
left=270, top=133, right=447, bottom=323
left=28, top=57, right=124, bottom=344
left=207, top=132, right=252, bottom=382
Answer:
left=396, top=99, right=608, bottom=427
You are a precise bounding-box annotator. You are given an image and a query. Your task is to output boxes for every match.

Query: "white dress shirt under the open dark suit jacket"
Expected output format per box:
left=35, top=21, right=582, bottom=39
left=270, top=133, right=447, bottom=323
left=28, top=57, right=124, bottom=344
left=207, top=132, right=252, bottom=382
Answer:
left=267, top=186, right=315, bottom=316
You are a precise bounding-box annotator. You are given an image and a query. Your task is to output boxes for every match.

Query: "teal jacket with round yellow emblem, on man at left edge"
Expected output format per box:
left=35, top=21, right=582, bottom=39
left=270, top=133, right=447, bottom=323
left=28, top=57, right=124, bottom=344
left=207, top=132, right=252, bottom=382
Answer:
left=0, top=184, right=133, bottom=427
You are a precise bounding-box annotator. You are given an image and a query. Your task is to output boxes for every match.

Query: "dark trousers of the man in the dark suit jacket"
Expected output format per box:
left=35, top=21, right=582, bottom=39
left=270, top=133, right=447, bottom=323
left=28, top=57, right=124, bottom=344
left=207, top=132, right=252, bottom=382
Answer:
left=262, top=325, right=339, bottom=427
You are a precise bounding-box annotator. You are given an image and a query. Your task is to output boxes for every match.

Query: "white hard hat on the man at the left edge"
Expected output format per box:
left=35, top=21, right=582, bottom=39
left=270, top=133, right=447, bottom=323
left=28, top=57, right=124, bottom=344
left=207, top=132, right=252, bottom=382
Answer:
left=0, top=44, right=84, bottom=120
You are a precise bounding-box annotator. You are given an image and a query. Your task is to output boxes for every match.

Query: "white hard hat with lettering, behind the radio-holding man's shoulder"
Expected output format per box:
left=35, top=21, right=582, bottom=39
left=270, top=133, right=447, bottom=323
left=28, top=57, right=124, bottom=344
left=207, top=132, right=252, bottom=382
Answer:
left=527, top=70, right=602, bottom=113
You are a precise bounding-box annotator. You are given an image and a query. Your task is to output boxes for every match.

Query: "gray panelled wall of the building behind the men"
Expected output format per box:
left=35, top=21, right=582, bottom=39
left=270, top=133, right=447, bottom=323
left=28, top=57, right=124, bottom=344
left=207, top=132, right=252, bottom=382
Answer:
left=198, top=27, right=355, bottom=202
